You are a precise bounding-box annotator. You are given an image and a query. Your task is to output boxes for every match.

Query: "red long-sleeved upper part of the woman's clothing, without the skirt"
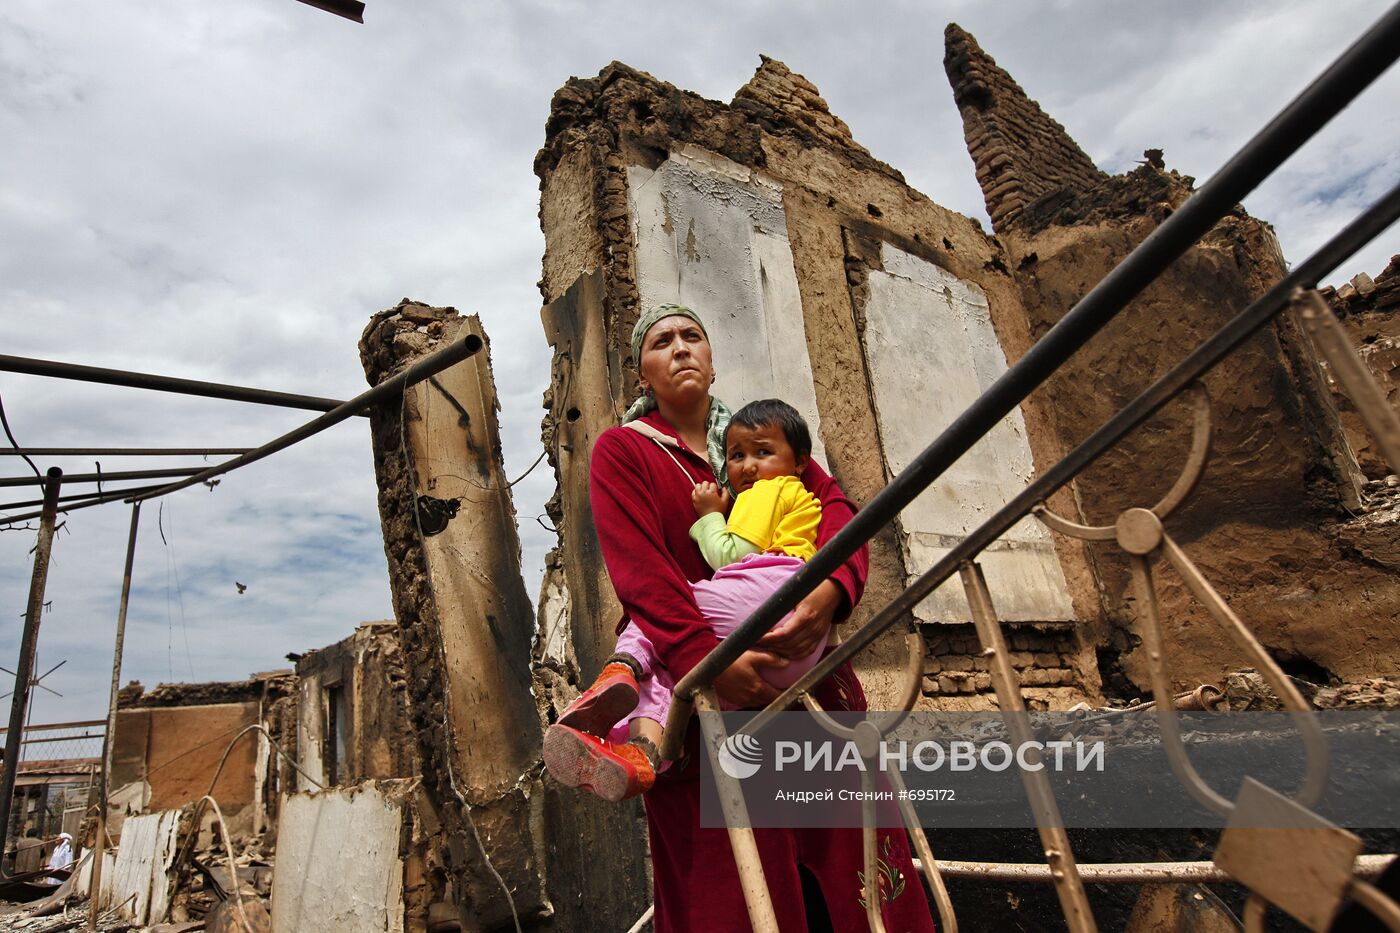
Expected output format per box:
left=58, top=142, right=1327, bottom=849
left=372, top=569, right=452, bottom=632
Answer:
left=589, top=412, right=869, bottom=679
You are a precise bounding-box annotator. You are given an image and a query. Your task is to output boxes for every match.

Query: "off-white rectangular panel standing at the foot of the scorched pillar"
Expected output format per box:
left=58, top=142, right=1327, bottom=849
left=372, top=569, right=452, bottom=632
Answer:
left=272, top=785, right=406, bottom=933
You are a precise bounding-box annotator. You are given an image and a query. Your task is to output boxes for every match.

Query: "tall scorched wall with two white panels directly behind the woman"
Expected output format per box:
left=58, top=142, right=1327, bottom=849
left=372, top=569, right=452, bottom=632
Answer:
left=536, top=57, right=1098, bottom=734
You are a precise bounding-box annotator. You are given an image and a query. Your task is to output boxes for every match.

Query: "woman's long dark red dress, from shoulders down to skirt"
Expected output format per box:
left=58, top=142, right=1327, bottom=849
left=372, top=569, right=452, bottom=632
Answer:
left=589, top=412, right=934, bottom=933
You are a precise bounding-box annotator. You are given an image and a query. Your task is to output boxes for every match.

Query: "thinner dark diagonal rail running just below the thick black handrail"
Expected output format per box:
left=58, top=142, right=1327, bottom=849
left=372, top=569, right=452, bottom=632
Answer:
left=744, top=176, right=1400, bottom=744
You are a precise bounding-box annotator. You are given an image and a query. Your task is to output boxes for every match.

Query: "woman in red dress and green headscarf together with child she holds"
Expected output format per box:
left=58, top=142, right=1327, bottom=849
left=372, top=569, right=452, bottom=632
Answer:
left=546, top=305, right=934, bottom=933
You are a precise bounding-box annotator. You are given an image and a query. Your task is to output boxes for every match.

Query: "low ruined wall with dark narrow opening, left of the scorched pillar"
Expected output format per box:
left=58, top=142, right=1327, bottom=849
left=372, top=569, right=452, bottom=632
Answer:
left=295, top=622, right=419, bottom=790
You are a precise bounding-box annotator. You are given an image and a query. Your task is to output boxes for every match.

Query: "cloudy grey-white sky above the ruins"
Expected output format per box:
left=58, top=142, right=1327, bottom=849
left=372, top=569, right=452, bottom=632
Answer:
left=0, top=0, right=1400, bottom=723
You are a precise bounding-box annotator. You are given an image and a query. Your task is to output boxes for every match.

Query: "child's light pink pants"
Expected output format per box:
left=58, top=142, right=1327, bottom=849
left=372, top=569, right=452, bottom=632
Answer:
left=608, top=553, right=826, bottom=742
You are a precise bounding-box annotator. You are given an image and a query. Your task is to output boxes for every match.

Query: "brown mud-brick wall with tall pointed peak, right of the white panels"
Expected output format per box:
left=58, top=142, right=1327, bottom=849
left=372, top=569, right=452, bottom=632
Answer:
left=948, top=28, right=1400, bottom=695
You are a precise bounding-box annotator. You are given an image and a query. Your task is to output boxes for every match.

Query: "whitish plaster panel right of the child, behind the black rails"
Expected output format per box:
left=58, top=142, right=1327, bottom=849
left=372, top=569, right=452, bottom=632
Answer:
left=864, top=244, right=1074, bottom=622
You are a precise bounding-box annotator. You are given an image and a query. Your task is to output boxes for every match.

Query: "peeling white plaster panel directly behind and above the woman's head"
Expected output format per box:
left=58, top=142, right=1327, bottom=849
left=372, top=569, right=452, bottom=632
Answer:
left=627, top=146, right=826, bottom=462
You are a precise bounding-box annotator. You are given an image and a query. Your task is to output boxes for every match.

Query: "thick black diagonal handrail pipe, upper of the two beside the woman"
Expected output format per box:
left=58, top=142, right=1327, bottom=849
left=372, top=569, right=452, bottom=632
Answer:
left=672, top=4, right=1400, bottom=706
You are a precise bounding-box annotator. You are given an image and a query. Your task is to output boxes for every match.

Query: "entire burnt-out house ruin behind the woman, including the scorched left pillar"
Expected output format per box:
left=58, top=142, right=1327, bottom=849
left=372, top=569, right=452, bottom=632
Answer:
left=341, top=25, right=1400, bottom=930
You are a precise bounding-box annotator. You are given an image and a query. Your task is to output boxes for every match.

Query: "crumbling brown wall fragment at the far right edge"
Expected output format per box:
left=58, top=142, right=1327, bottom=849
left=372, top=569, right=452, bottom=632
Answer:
left=1323, top=256, right=1400, bottom=479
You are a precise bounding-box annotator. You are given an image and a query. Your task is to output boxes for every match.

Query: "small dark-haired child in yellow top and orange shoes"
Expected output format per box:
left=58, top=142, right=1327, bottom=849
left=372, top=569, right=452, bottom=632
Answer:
left=545, top=399, right=826, bottom=800
